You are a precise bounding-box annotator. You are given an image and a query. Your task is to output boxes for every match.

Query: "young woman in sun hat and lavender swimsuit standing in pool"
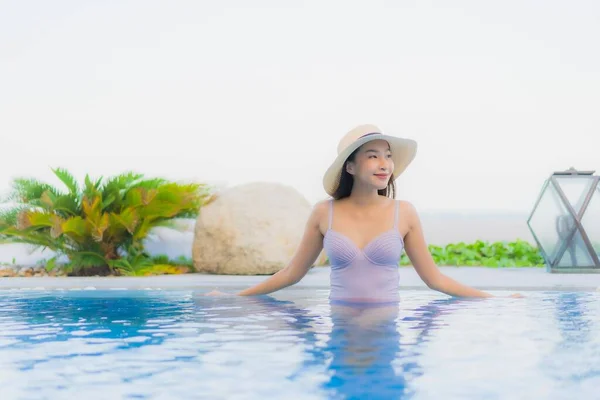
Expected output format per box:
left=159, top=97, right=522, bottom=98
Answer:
left=209, top=125, right=518, bottom=303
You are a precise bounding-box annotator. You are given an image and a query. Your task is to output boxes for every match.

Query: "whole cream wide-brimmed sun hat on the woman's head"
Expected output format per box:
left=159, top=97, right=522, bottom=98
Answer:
left=323, top=125, right=417, bottom=196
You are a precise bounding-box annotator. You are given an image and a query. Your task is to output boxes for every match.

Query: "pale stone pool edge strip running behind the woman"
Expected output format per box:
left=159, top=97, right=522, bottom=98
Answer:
left=0, top=267, right=600, bottom=291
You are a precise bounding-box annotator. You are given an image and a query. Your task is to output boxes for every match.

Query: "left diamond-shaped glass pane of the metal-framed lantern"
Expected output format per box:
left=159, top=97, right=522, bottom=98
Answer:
left=529, top=182, right=575, bottom=264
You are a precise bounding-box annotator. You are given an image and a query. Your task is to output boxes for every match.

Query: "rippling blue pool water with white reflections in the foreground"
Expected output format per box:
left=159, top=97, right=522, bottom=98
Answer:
left=0, top=289, right=600, bottom=400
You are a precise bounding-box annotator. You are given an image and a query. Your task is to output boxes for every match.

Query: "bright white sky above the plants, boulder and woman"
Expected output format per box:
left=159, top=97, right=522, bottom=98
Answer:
left=0, top=0, right=600, bottom=211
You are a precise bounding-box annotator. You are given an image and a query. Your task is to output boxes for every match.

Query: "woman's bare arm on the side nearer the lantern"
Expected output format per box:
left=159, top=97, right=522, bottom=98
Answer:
left=403, top=202, right=493, bottom=297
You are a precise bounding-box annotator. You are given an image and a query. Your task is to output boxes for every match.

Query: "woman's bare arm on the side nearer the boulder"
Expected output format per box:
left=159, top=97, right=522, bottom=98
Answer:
left=237, top=202, right=328, bottom=296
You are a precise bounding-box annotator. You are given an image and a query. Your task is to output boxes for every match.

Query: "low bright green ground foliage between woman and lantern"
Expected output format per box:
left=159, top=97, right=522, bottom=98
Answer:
left=400, top=240, right=544, bottom=267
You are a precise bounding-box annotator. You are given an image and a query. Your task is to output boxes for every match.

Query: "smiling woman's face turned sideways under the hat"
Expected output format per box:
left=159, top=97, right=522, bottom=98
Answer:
left=346, top=139, right=394, bottom=190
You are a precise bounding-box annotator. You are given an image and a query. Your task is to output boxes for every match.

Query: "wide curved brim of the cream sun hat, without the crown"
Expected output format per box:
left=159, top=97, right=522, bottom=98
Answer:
left=323, top=134, right=417, bottom=196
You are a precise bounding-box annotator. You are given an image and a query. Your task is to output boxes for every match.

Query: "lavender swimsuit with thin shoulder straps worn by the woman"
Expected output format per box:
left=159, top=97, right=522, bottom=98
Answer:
left=323, top=200, right=404, bottom=302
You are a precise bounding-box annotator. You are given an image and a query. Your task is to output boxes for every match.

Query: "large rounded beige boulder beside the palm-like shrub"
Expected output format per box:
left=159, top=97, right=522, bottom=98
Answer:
left=192, top=183, right=324, bottom=275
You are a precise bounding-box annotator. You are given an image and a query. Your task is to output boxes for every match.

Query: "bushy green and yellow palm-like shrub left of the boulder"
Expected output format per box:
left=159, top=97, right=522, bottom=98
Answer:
left=0, top=168, right=210, bottom=274
